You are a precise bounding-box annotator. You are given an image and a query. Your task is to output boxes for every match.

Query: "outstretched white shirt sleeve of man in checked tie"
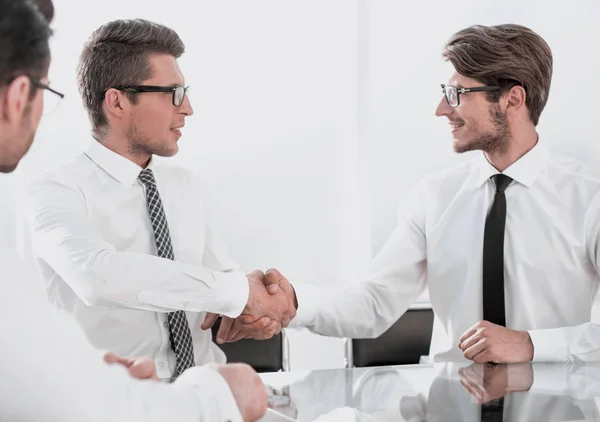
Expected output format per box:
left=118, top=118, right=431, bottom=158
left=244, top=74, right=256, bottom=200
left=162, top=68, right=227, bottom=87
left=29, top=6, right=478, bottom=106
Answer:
left=28, top=177, right=248, bottom=317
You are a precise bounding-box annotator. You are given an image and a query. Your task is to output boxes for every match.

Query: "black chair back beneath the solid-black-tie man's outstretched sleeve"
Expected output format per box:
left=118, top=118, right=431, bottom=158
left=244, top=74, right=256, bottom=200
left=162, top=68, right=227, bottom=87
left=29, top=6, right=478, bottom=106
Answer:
left=346, top=306, right=433, bottom=367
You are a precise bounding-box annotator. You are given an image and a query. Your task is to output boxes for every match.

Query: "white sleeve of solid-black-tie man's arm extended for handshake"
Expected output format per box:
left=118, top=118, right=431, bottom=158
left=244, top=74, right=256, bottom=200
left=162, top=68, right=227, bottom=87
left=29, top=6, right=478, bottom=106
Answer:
left=290, top=182, right=427, bottom=338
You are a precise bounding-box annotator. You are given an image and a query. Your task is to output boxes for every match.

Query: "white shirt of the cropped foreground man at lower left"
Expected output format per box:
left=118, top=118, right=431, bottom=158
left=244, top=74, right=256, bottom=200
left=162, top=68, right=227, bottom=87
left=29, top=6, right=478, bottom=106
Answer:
left=0, top=239, right=242, bottom=422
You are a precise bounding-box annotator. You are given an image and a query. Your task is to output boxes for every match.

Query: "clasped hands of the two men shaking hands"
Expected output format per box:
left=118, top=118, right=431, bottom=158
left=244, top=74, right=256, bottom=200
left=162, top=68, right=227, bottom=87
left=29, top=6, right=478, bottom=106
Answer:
left=202, top=269, right=298, bottom=344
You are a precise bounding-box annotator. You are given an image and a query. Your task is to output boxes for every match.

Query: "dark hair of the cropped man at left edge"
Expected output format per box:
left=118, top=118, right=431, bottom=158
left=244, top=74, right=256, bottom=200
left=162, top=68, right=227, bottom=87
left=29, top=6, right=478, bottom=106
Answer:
left=0, top=0, right=52, bottom=87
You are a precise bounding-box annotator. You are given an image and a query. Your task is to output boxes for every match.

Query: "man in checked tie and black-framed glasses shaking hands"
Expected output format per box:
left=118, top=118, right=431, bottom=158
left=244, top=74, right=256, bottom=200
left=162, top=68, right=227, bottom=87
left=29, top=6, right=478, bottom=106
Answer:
left=29, top=19, right=295, bottom=378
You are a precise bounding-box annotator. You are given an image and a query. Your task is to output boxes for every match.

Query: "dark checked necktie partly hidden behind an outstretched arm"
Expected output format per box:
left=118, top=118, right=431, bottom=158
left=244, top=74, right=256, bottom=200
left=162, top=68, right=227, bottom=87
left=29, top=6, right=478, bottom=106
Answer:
left=139, top=169, right=194, bottom=377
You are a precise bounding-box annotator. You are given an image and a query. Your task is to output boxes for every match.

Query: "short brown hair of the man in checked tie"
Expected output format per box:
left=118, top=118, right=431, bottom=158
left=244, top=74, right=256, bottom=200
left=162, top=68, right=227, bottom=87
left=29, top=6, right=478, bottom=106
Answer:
left=77, top=19, right=185, bottom=131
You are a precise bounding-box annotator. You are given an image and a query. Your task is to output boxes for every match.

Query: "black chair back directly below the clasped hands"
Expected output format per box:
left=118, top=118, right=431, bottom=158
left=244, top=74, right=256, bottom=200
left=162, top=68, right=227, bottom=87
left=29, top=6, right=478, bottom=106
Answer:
left=212, top=318, right=289, bottom=372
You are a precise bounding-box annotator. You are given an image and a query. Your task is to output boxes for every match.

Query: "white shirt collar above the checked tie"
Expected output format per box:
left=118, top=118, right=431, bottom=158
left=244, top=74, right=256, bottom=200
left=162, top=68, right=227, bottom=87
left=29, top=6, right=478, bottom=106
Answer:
left=85, top=139, right=154, bottom=186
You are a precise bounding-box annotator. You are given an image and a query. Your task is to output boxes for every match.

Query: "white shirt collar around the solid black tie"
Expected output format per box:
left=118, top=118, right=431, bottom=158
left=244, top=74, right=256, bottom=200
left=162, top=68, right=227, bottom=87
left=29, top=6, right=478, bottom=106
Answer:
left=477, top=140, right=548, bottom=188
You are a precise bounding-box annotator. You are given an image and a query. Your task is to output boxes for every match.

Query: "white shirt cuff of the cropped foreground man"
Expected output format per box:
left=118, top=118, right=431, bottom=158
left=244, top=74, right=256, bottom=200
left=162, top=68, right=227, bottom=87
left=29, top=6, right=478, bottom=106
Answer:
left=174, top=366, right=243, bottom=422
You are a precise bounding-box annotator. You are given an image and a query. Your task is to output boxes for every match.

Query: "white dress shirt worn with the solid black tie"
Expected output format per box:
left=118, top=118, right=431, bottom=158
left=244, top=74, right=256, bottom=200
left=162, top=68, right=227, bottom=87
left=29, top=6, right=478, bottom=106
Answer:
left=293, top=142, right=600, bottom=361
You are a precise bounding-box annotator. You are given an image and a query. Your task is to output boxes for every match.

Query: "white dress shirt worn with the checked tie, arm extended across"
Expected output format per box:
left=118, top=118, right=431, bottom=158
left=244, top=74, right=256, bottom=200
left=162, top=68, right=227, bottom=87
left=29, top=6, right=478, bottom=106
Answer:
left=28, top=140, right=248, bottom=378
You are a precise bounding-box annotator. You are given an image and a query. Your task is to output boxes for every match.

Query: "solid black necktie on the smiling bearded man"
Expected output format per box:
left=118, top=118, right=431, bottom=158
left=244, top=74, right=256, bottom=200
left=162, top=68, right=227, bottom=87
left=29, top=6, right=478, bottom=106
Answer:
left=483, top=174, right=512, bottom=327
